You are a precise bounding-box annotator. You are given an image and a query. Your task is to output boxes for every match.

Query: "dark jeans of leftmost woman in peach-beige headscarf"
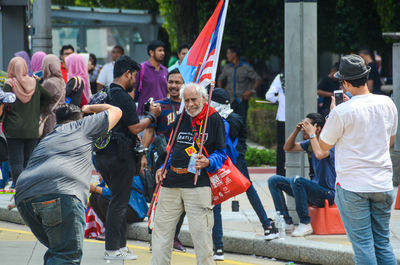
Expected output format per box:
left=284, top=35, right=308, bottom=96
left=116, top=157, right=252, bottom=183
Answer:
left=7, top=138, right=38, bottom=184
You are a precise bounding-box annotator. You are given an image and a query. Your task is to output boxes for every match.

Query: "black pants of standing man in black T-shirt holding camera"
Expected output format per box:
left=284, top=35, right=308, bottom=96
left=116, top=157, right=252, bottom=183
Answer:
left=96, top=152, right=136, bottom=250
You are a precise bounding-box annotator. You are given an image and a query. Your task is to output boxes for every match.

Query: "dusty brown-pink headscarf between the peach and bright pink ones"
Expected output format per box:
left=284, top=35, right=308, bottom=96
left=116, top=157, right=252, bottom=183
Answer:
left=42, top=54, right=65, bottom=93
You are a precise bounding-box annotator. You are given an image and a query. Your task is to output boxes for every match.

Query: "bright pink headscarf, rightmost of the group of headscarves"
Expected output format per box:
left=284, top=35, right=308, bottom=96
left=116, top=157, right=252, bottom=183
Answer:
left=65, top=53, right=91, bottom=106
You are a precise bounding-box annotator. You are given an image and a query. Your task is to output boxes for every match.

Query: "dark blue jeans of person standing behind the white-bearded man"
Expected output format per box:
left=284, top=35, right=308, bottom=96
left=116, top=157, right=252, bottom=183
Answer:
left=213, top=154, right=270, bottom=249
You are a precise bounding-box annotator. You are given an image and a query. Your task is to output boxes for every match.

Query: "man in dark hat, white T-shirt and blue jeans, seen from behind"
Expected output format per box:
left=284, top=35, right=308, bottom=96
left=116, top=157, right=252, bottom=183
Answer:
left=319, top=55, right=398, bottom=265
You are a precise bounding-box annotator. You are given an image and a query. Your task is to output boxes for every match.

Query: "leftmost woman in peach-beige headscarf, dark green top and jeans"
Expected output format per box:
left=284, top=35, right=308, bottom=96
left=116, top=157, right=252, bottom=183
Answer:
left=3, top=57, right=51, bottom=184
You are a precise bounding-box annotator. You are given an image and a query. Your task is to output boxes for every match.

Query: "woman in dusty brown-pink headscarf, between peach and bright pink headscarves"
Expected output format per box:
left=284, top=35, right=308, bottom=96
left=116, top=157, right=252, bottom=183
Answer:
left=40, top=54, right=65, bottom=138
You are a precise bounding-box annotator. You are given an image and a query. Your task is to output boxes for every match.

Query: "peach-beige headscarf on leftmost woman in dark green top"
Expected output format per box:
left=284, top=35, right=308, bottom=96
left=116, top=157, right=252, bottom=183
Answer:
left=5, top=57, right=36, bottom=103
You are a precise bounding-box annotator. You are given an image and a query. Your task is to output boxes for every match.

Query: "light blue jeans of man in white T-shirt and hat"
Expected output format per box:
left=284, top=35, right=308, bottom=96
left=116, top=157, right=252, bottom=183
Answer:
left=335, top=186, right=397, bottom=265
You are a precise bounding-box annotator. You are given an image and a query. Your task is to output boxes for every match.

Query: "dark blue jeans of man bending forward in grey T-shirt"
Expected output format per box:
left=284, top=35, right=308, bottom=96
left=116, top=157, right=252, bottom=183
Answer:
left=17, top=194, right=86, bottom=264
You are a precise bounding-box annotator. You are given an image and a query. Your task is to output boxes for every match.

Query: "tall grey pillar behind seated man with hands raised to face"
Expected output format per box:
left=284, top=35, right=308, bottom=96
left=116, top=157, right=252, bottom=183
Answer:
left=285, top=0, right=317, bottom=222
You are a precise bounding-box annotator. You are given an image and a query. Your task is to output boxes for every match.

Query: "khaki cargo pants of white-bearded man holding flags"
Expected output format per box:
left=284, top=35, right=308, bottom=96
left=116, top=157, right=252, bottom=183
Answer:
left=150, top=187, right=214, bottom=265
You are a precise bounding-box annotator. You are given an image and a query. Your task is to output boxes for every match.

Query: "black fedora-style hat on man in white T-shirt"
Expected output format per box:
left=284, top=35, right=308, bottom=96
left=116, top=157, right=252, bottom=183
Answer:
left=334, top=54, right=371, bottom=80
